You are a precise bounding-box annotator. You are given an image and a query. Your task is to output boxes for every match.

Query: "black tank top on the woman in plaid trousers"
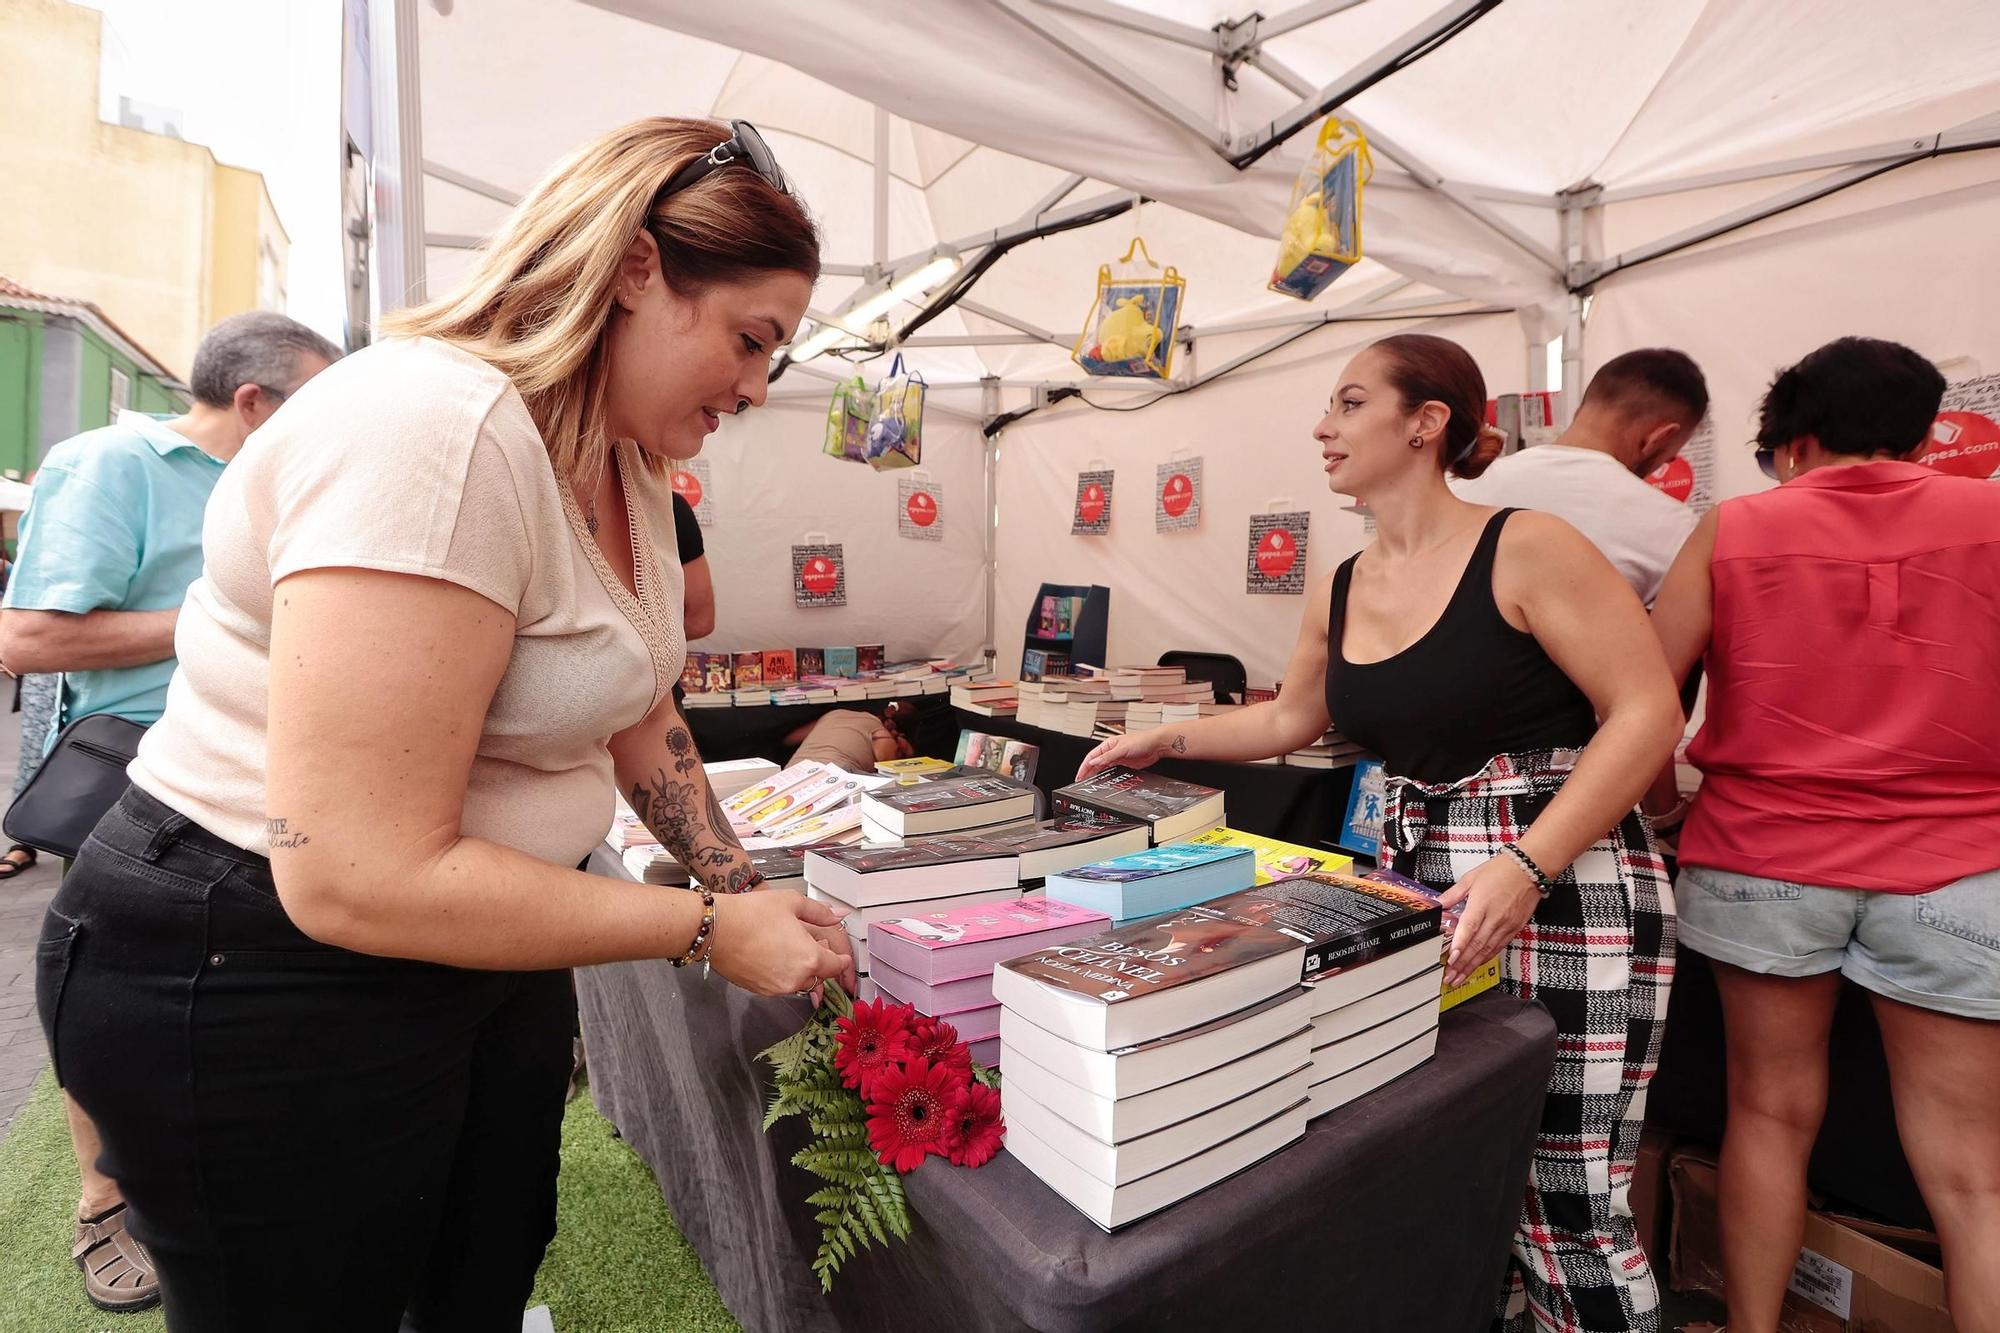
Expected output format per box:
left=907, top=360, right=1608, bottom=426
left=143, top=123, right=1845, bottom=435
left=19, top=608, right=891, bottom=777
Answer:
left=1326, top=508, right=1598, bottom=783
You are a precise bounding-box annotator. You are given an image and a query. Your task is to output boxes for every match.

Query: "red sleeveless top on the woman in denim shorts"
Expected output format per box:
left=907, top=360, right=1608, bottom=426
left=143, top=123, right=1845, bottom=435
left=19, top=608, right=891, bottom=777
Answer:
left=1680, top=462, right=2000, bottom=893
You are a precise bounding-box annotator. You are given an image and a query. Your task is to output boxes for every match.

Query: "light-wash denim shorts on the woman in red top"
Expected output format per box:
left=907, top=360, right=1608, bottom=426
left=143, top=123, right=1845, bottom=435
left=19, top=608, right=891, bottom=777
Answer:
left=1678, top=865, right=2000, bottom=1019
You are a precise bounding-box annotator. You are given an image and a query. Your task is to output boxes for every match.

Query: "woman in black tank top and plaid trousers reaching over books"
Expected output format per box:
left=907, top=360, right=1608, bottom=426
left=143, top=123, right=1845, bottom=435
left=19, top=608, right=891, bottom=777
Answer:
left=1080, top=334, right=1682, bottom=1333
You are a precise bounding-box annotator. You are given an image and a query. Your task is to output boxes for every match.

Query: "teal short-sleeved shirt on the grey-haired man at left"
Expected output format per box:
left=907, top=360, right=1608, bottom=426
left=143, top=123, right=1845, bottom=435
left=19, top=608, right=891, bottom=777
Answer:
left=6, top=412, right=224, bottom=749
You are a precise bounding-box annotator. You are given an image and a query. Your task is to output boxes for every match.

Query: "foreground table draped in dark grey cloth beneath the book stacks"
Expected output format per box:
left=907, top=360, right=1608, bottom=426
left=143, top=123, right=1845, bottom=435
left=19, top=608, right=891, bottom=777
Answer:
left=576, top=849, right=1556, bottom=1333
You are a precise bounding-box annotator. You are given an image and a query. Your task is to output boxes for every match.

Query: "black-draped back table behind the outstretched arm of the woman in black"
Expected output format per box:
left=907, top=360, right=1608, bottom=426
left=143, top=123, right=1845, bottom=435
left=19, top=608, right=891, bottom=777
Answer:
left=956, top=709, right=1354, bottom=847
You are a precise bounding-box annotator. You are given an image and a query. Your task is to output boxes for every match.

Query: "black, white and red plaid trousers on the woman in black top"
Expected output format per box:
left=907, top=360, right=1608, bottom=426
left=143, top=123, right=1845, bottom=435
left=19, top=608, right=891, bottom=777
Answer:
left=1382, top=751, right=1674, bottom=1333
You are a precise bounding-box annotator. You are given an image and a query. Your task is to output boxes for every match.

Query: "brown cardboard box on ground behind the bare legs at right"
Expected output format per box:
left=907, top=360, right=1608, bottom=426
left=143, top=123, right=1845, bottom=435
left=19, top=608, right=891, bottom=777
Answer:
left=1668, top=1151, right=1956, bottom=1333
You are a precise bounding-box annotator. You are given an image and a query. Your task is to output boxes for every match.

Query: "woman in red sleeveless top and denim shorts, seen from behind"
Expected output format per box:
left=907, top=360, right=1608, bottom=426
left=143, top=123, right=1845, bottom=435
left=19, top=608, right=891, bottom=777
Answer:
left=1654, top=338, right=2000, bottom=1333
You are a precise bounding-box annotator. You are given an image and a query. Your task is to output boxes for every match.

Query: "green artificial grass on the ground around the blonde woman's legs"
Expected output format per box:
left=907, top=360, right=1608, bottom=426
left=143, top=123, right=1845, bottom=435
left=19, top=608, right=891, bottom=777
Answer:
left=0, top=1073, right=736, bottom=1333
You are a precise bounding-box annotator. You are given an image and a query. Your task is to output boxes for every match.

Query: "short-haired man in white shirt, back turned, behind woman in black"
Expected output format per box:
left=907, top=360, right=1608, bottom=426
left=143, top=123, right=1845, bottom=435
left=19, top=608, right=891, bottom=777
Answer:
left=1452, top=346, right=1708, bottom=606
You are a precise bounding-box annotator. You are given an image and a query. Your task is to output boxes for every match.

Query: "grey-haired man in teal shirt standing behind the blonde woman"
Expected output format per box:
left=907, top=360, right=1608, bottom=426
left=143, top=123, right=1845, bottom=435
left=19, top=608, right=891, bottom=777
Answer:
left=0, top=312, right=340, bottom=1309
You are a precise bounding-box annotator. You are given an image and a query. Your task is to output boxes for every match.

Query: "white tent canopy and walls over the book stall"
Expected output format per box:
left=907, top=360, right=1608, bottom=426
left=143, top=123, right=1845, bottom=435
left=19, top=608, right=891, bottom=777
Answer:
left=372, top=0, right=2000, bottom=681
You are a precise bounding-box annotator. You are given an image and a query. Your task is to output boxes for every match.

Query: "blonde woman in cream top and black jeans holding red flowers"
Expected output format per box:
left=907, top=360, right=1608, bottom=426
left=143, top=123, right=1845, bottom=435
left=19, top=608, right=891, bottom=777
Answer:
left=38, top=118, right=852, bottom=1333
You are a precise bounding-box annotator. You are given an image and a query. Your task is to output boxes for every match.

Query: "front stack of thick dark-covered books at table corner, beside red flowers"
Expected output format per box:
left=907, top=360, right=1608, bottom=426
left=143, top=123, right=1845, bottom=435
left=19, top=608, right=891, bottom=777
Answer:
left=994, top=913, right=1312, bottom=1231
